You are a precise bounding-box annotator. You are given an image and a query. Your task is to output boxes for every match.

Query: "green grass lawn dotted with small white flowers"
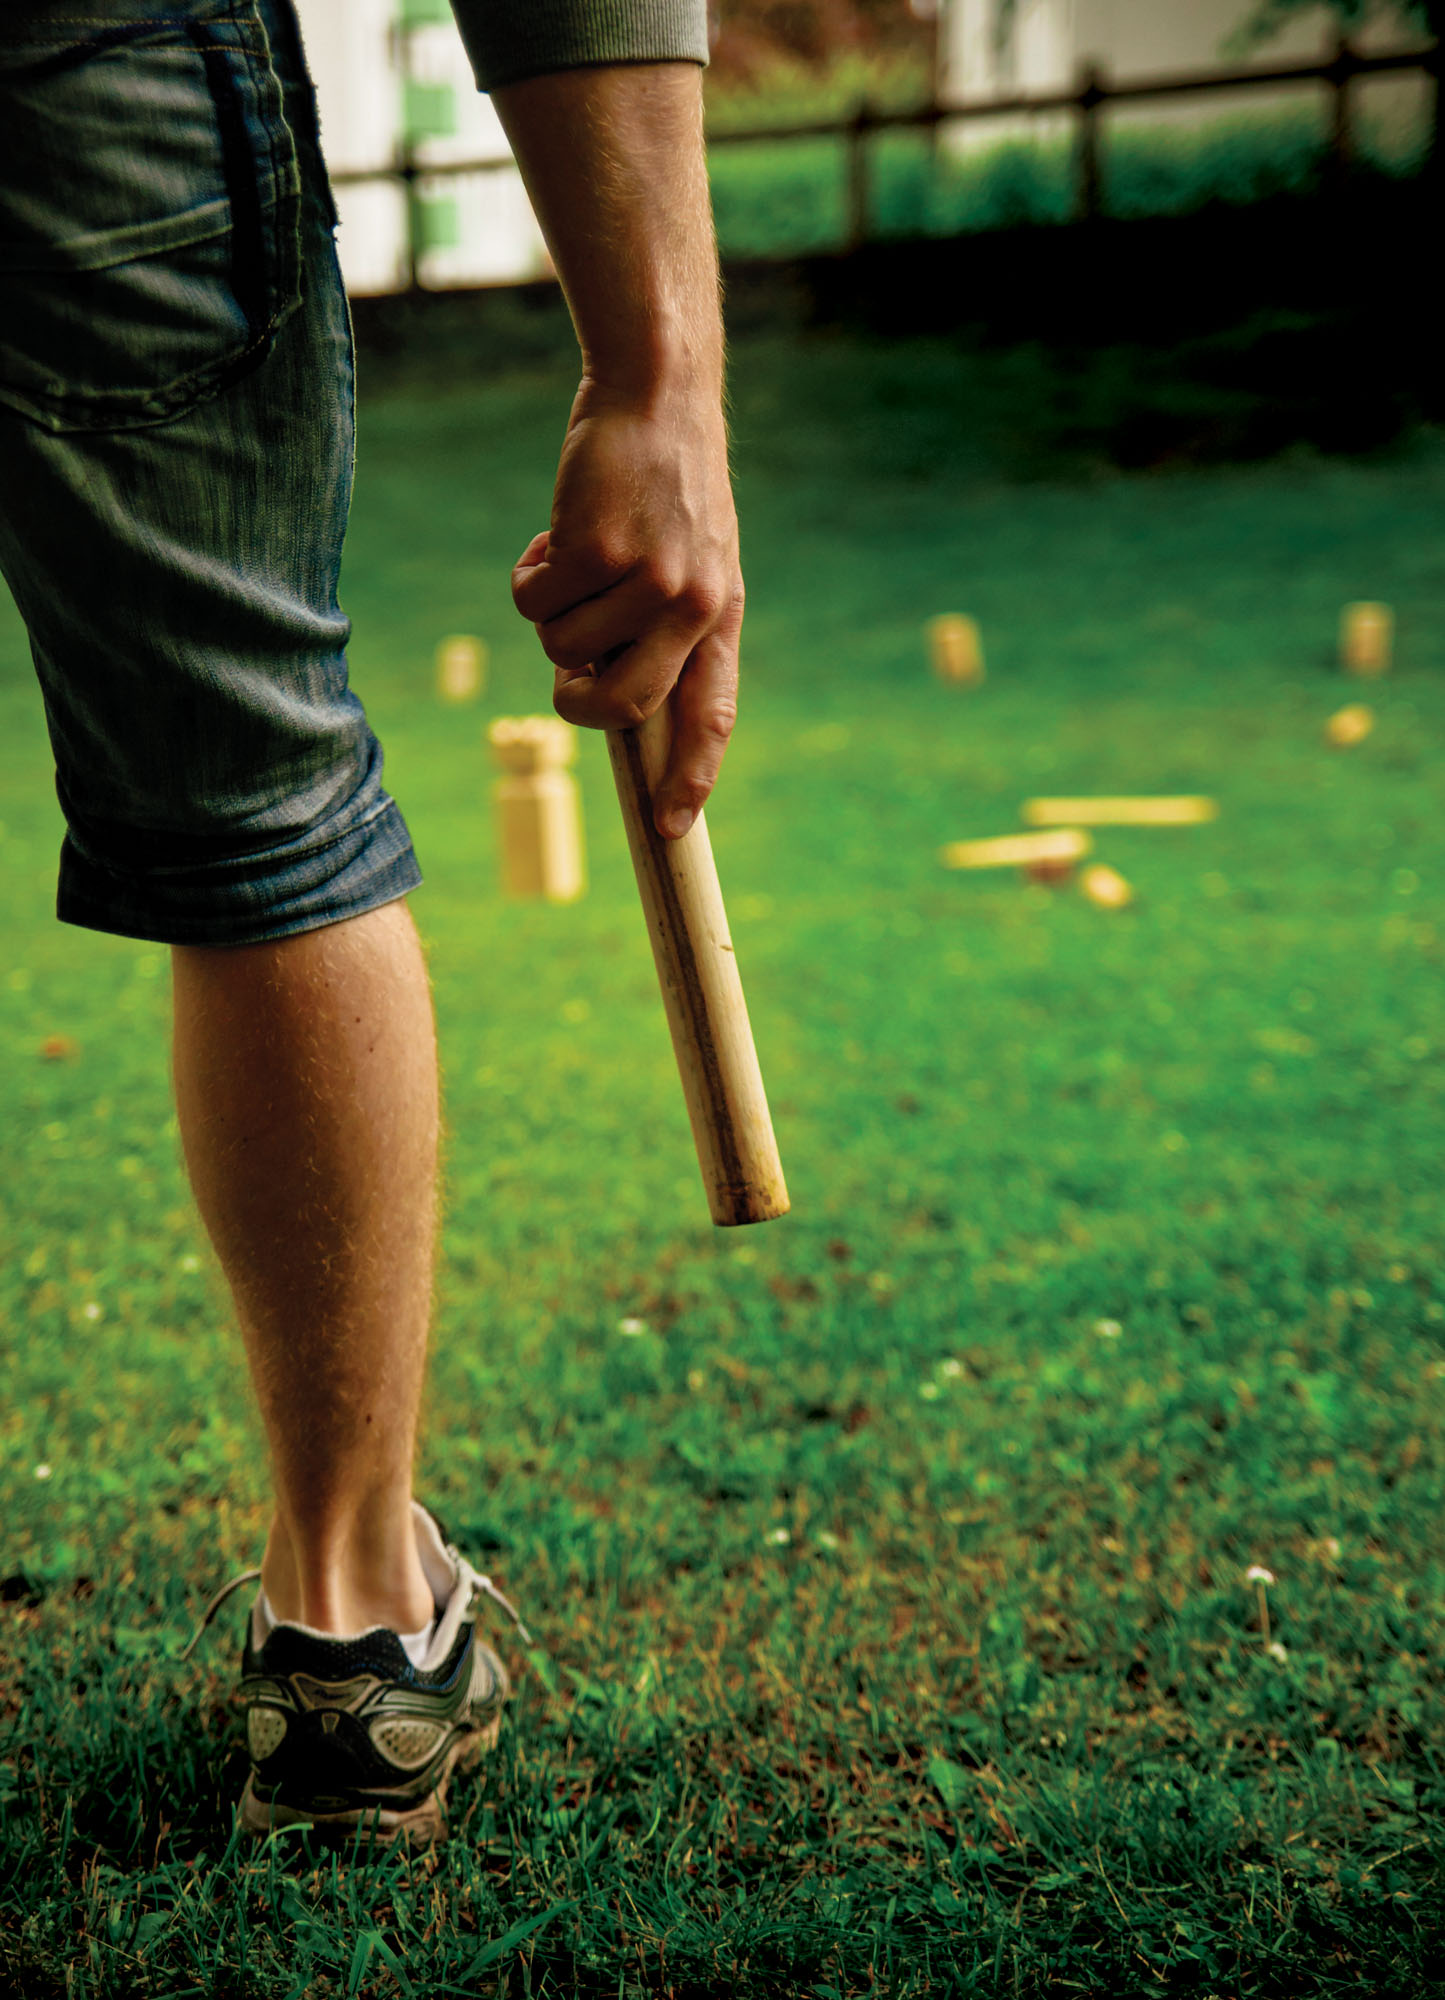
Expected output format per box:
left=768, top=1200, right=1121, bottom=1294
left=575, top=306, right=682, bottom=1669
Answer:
left=0, top=320, right=1445, bottom=2000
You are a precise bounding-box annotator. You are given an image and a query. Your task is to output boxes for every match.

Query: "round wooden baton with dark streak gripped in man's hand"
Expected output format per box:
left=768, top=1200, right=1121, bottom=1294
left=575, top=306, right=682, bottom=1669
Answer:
left=606, top=704, right=789, bottom=1228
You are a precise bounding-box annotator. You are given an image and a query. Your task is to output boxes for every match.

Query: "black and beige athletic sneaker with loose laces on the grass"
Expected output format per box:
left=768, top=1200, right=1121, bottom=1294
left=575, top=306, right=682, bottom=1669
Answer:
left=182, top=1502, right=530, bottom=1842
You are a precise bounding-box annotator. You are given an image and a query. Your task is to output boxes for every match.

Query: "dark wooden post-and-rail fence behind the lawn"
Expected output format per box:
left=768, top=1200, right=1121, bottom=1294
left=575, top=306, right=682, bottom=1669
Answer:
left=332, top=36, right=1445, bottom=286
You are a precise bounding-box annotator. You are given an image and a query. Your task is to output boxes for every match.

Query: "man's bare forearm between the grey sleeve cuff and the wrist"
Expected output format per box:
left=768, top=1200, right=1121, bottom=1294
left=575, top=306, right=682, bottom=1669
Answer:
left=492, top=62, right=723, bottom=402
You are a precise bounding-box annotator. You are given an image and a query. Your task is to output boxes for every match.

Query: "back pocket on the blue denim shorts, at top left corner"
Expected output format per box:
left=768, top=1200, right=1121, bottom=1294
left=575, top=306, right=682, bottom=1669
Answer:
left=0, top=0, right=300, bottom=430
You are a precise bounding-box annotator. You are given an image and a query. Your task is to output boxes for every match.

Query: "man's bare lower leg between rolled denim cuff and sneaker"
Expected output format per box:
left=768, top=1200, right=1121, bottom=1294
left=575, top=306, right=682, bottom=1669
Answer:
left=172, top=902, right=438, bottom=1632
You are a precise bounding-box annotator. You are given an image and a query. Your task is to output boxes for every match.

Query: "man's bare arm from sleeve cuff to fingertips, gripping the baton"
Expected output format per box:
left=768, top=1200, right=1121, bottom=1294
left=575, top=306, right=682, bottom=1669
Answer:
left=494, top=64, right=743, bottom=838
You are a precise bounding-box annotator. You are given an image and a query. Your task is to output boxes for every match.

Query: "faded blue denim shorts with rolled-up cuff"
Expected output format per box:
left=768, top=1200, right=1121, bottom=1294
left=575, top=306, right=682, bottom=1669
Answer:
left=0, top=0, right=420, bottom=944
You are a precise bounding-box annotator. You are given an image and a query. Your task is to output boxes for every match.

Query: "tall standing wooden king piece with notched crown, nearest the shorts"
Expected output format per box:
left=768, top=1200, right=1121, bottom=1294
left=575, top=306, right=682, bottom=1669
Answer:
left=486, top=716, right=586, bottom=902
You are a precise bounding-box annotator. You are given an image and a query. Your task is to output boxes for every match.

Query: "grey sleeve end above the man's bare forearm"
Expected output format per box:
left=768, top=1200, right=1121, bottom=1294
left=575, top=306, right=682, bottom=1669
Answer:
left=452, top=0, right=706, bottom=90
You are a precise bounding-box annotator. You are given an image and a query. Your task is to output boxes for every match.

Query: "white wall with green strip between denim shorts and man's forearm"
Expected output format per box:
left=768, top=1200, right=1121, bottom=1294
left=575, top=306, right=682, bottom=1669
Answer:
left=286, top=0, right=550, bottom=296
